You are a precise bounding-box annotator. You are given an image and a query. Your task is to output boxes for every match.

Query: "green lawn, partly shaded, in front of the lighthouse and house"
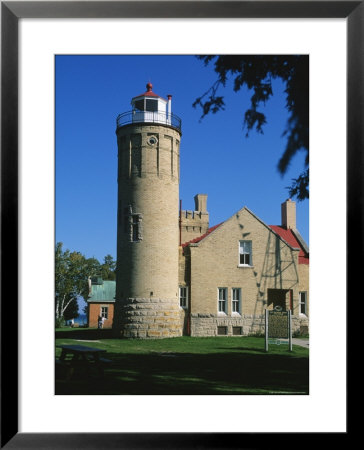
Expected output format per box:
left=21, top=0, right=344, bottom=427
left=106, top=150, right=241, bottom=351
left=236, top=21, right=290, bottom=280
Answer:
left=56, top=328, right=309, bottom=395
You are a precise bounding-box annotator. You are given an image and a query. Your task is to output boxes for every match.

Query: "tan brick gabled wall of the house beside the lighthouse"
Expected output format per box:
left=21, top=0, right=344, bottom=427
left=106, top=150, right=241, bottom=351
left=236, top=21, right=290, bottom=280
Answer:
left=180, top=208, right=308, bottom=336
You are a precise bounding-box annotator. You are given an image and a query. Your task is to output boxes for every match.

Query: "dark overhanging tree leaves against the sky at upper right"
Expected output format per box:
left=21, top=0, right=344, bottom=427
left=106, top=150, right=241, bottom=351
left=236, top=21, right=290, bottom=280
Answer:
left=193, top=55, right=309, bottom=199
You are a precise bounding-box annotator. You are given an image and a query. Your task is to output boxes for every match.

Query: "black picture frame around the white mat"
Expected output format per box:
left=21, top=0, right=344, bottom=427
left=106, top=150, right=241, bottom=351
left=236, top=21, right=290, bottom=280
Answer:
left=1, top=0, right=358, bottom=449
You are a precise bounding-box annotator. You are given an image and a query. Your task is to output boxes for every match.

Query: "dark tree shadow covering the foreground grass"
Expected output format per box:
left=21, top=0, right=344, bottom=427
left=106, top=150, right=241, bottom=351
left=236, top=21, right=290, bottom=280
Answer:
left=55, top=348, right=309, bottom=395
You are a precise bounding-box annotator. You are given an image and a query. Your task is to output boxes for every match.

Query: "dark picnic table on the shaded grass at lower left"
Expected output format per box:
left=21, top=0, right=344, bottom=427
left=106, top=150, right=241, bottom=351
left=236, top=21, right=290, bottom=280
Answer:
left=56, top=345, right=111, bottom=380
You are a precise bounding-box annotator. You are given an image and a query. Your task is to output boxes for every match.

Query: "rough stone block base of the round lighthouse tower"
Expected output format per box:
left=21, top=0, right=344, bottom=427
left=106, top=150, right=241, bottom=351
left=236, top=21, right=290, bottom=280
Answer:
left=114, top=298, right=183, bottom=339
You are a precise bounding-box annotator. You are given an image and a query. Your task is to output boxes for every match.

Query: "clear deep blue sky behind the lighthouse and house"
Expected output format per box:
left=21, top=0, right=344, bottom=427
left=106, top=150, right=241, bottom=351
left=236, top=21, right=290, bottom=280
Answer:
left=55, top=55, right=309, bottom=262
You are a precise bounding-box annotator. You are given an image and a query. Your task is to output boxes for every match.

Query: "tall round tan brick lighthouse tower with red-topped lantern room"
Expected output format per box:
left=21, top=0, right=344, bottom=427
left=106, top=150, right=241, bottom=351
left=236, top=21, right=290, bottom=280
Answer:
left=113, top=83, right=182, bottom=338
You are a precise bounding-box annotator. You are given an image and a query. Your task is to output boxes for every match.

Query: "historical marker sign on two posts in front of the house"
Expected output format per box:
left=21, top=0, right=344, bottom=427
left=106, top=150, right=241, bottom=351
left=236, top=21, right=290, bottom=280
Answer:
left=265, top=306, right=292, bottom=351
